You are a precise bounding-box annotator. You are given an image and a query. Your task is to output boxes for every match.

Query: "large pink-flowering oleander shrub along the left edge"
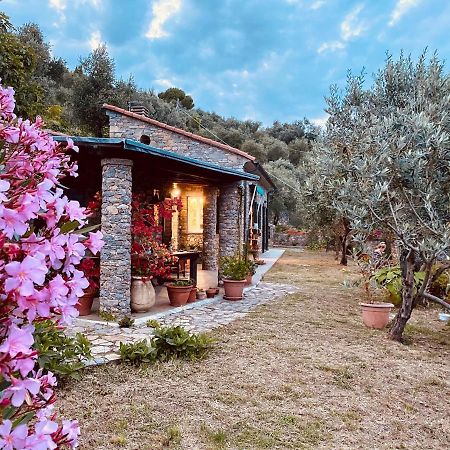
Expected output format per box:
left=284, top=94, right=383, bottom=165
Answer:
left=0, top=84, right=103, bottom=450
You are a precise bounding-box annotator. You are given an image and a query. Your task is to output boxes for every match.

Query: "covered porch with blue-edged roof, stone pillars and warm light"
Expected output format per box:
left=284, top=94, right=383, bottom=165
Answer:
left=58, top=137, right=259, bottom=319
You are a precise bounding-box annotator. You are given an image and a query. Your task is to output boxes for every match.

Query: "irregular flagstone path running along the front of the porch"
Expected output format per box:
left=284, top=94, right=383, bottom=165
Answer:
left=70, top=282, right=299, bottom=365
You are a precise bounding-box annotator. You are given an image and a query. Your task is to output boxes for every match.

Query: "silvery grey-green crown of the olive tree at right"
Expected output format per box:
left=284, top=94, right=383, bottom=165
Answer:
left=309, top=55, right=450, bottom=261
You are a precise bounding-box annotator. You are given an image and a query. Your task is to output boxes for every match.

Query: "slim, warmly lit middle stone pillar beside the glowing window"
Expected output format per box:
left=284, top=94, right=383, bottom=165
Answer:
left=203, top=187, right=219, bottom=270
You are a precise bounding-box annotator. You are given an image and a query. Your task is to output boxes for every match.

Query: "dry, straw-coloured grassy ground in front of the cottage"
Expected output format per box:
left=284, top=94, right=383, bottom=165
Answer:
left=58, top=250, right=450, bottom=450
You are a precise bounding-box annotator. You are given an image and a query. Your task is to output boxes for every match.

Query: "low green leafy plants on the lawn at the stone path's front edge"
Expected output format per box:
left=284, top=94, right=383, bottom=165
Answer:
left=120, top=326, right=214, bottom=365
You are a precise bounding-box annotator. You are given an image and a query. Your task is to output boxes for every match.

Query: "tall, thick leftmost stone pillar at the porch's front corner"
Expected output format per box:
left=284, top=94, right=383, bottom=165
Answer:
left=100, top=158, right=133, bottom=317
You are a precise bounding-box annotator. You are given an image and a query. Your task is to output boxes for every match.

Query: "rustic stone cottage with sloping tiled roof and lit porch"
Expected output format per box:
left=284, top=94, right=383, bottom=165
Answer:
left=57, top=104, right=274, bottom=315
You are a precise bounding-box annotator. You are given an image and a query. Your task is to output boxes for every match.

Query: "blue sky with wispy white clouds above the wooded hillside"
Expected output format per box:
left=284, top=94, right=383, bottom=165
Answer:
left=0, top=0, right=450, bottom=125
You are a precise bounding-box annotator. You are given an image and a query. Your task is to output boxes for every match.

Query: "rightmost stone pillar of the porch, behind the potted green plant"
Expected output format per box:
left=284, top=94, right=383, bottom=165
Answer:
left=219, top=182, right=243, bottom=257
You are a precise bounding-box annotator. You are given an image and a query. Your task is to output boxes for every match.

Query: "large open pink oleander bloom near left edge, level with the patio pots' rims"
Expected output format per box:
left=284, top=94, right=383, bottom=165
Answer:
left=5, top=255, right=48, bottom=296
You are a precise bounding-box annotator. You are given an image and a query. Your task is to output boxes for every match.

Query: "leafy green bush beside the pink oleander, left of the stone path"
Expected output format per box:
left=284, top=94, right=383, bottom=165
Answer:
left=33, top=320, right=92, bottom=379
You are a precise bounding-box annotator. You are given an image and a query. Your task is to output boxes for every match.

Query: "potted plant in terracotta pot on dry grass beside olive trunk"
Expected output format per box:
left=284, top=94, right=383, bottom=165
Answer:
left=354, top=248, right=394, bottom=329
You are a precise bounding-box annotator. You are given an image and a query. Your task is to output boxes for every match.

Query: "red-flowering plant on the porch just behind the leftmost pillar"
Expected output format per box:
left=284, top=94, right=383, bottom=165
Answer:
left=131, top=194, right=182, bottom=278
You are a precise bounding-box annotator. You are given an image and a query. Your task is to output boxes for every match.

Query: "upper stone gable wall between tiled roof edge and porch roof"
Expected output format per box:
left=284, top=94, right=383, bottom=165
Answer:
left=106, top=110, right=248, bottom=170
